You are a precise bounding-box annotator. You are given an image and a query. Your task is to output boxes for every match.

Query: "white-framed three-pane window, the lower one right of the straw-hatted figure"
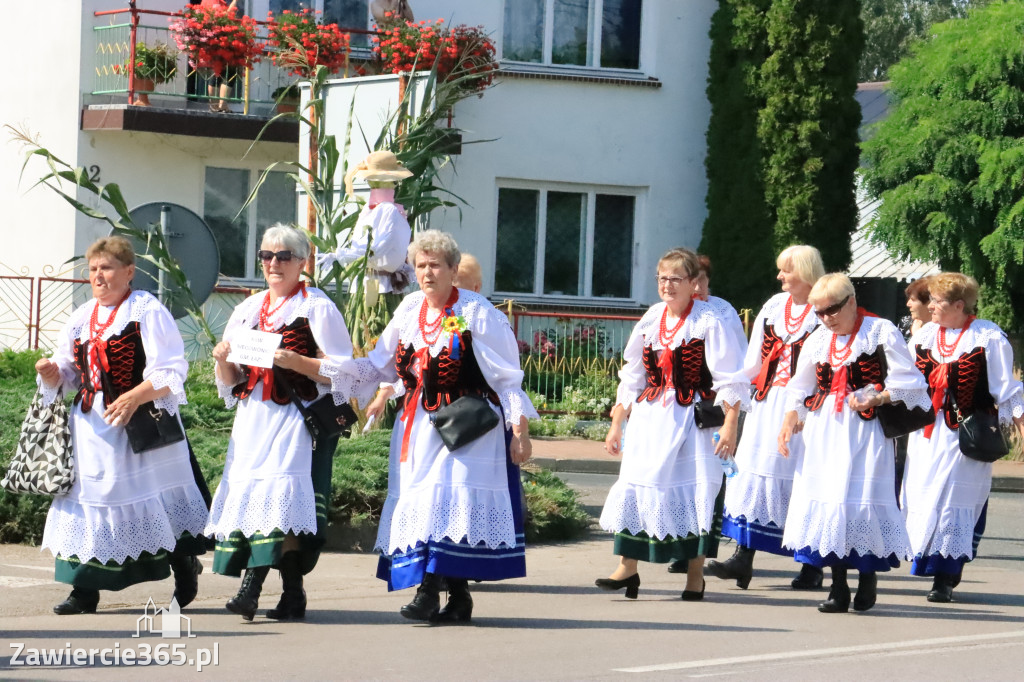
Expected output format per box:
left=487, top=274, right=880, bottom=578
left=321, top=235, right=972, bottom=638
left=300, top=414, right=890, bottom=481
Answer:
left=495, top=186, right=636, bottom=298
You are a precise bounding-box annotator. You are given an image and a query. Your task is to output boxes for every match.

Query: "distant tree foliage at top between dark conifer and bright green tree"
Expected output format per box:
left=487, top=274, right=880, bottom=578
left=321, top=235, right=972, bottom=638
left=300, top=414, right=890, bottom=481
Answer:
left=857, top=0, right=989, bottom=81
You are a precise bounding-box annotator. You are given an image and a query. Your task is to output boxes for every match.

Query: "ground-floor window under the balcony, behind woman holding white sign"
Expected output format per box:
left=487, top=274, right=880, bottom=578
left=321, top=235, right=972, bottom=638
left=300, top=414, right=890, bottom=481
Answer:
left=203, top=166, right=297, bottom=280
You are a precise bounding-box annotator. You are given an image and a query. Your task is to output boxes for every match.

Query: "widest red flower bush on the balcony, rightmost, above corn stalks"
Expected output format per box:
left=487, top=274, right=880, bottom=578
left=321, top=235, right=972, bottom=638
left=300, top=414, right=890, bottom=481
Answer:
left=373, top=12, right=498, bottom=92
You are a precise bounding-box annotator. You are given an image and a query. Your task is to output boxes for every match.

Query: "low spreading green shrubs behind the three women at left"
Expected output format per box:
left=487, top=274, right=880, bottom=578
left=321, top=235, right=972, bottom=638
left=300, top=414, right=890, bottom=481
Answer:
left=0, top=350, right=589, bottom=545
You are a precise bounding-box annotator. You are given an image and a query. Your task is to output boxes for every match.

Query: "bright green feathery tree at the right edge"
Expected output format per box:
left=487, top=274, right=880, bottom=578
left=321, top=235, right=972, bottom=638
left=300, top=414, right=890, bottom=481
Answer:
left=863, top=2, right=1024, bottom=331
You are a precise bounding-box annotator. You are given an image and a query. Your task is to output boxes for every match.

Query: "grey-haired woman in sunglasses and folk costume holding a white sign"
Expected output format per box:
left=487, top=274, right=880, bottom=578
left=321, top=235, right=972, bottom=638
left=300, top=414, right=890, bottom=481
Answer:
left=206, top=225, right=352, bottom=621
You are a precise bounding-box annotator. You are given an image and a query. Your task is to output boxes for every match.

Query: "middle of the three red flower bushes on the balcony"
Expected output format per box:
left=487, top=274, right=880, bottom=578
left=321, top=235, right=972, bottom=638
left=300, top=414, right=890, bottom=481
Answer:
left=267, top=9, right=349, bottom=78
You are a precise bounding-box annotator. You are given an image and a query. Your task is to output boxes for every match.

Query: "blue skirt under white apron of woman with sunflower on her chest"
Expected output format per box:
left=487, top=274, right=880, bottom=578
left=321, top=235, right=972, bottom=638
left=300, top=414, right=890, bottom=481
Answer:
left=377, top=430, right=526, bottom=592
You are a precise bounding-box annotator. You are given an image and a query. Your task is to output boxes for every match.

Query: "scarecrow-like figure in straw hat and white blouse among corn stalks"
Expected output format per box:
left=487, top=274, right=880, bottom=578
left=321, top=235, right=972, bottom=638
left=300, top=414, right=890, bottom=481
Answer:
left=317, top=151, right=414, bottom=323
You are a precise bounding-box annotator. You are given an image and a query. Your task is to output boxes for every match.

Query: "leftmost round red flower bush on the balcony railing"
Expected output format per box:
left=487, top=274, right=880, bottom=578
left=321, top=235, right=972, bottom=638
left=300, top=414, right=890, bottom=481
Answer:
left=171, top=5, right=263, bottom=76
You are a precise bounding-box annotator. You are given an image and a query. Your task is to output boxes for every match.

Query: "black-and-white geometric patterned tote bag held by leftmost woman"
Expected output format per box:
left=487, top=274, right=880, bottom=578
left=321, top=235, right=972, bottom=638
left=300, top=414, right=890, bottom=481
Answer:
left=0, top=392, right=75, bottom=495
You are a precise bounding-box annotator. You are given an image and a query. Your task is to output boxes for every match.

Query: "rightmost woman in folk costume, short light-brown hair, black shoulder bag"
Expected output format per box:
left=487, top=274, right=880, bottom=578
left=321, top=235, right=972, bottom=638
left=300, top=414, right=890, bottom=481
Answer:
left=902, top=272, right=1024, bottom=603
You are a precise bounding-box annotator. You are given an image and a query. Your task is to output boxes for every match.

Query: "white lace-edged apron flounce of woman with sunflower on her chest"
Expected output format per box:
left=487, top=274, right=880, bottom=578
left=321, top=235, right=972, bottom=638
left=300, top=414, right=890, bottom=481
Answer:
left=376, top=485, right=515, bottom=554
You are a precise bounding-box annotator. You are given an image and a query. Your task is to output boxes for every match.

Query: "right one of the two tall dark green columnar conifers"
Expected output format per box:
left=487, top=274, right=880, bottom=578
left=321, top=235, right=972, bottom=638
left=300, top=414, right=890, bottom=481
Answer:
left=758, top=0, right=863, bottom=270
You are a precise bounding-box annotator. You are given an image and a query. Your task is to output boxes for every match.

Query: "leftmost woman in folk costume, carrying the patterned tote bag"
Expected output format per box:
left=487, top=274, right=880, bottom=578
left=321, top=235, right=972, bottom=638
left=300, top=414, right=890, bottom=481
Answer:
left=36, top=237, right=209, bottom=615
